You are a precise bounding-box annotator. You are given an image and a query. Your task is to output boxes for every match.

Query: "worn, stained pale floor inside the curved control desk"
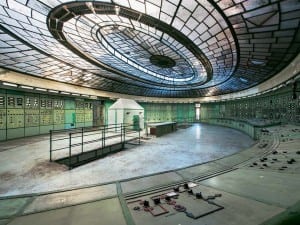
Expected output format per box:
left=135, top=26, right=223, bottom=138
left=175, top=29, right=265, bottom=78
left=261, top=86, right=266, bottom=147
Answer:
left=0, top=124, right=254, bottom=196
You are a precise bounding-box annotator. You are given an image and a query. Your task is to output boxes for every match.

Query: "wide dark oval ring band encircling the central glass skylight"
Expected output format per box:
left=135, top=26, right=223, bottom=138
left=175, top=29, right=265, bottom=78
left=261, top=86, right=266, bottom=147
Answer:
left=48, top=2, right=213, bottom=88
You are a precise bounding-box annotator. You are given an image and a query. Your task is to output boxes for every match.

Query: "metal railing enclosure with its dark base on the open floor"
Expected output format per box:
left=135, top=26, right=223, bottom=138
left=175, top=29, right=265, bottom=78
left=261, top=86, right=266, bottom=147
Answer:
left=50, top=124, right=141, bottom=169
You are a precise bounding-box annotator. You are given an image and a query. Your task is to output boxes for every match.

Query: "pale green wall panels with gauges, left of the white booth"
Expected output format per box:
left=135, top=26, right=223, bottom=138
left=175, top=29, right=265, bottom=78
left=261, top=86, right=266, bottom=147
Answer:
left=0, top=89, right=93, bottom=141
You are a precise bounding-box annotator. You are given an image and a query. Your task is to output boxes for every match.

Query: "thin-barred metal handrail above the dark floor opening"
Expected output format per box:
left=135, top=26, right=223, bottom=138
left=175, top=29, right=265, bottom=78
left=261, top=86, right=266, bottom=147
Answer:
left=50, top=124, right=140, bottom=169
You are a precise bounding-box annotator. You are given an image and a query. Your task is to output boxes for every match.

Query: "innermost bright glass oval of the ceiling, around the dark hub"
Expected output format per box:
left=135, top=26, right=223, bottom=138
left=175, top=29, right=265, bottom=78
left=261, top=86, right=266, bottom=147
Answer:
left=94, top=22, right=197, bottom=83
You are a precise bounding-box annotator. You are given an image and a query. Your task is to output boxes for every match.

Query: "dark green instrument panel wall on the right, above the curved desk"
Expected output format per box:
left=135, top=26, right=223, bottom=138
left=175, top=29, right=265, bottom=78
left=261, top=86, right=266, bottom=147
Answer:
left=201, top=82, right=300, bottom=124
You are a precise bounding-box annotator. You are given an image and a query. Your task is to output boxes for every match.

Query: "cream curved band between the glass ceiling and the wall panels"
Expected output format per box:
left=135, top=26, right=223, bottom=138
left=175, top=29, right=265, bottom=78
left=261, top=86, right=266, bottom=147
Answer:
left=0, top=53, right=300, bottom=103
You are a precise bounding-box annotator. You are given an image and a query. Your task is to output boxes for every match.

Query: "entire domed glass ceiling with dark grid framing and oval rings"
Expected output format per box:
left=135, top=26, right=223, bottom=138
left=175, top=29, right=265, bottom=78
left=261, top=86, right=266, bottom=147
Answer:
left=0, top=0, right=300, bottom=97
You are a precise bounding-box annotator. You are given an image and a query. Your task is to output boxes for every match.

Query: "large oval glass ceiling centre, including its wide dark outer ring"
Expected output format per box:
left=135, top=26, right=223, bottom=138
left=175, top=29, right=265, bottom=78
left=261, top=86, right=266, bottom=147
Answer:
left=48, top=2, right=213, bottom=90
